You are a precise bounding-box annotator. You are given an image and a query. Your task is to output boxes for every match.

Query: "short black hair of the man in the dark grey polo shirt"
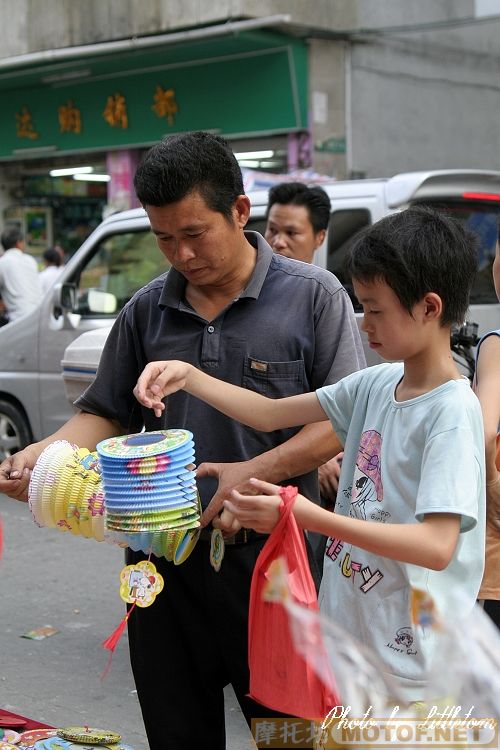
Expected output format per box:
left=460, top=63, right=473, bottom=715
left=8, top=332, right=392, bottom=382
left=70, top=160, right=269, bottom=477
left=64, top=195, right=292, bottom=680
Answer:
left=134, top=131, right=245, bottom=220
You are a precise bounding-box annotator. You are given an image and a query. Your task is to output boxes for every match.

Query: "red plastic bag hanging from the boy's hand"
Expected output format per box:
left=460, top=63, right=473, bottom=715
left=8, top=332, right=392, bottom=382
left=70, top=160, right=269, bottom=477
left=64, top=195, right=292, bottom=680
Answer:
left=248, top=487, right=337, bottom=719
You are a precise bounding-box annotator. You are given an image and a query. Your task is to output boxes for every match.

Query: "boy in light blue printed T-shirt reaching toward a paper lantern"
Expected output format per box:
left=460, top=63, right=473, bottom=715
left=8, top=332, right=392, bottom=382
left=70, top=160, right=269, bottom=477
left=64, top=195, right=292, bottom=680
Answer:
left=135, top=207, right=485, bottom=702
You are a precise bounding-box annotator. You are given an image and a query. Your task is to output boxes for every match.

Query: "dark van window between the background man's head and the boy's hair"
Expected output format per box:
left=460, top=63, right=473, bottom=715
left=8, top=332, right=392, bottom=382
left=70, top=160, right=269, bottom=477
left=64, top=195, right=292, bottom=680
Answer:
left=326, top=208, right=372, bottom=311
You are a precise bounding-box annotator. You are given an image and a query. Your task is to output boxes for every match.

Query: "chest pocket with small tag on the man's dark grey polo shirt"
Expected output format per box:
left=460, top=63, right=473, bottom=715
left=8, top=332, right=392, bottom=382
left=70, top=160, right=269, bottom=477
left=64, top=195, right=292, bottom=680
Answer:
left=242, top=356, right=308, bottom=398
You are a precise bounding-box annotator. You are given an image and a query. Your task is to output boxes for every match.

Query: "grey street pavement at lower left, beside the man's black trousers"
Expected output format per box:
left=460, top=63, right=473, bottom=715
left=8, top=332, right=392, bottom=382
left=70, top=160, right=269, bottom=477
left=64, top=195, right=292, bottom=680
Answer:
left=0, top=495, right=255, bottom=750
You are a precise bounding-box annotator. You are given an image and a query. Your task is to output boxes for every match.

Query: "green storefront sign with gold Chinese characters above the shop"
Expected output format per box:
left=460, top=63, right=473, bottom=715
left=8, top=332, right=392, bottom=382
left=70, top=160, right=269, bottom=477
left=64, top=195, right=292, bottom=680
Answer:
left=0, top=30, right=307, bottom=161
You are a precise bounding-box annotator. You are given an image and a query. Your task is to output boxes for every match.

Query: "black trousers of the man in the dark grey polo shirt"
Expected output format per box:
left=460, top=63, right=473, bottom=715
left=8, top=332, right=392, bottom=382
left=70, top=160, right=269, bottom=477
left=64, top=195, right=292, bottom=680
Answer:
left=127, top=540, right=298, bottom=750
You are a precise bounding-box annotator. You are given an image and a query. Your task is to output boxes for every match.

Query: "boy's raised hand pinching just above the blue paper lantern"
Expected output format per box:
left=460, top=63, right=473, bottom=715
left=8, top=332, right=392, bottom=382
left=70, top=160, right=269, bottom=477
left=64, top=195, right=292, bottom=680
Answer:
left=134, top=360, right=192, bottom=417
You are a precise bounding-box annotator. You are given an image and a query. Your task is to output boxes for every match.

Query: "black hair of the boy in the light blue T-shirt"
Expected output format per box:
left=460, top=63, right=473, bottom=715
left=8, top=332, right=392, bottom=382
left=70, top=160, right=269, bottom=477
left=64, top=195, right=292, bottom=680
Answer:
left=347, top=206, right=477, bottom=326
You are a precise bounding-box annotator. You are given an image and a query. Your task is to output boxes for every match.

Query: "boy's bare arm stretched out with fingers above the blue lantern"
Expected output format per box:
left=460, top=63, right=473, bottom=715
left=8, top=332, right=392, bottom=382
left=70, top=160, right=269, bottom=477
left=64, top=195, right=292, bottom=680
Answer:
left=134, top=360, right=331, bottom=432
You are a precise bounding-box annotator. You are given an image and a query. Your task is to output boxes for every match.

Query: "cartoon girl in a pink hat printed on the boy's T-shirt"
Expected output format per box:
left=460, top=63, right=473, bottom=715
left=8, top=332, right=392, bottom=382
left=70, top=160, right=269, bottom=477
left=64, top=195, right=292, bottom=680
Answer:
left=349, top=430, right=384, bottom=520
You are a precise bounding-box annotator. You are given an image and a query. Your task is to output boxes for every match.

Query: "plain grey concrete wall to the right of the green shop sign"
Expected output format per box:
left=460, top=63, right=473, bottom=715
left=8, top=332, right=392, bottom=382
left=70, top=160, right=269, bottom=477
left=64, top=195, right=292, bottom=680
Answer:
left=350, top=13, right=500, bottom=177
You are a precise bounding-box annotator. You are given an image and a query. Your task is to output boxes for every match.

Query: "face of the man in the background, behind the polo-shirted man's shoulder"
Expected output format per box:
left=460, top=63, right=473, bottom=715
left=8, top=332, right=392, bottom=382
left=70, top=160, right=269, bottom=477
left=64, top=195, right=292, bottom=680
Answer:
left=265, top=203, right=326, bottom=263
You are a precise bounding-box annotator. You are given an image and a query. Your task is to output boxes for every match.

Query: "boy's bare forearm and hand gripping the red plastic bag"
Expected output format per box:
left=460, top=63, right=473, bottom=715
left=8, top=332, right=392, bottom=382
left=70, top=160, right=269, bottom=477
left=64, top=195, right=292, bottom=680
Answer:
left=224, top=479, right=460, bottom=570
